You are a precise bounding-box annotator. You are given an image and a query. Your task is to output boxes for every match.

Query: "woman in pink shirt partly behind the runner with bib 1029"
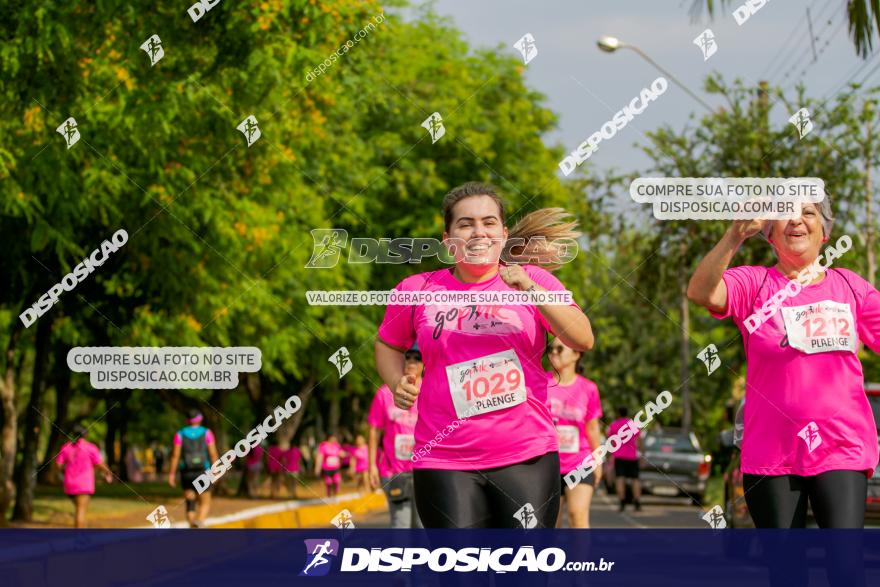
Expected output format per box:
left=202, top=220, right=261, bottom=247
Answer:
left=547, top=339, right=602, bottom=528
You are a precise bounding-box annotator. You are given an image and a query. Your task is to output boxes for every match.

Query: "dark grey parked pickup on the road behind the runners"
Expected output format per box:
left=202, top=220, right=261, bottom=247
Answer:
left=639, top=428, right=712, bottom=505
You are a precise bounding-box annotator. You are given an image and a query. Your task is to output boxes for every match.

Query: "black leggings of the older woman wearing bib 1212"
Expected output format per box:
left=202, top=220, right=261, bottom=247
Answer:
left=743, top=471, right=868, bottom=528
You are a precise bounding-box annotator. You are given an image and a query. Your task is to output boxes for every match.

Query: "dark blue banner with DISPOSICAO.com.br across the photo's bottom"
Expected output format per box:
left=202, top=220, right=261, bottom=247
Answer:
left=0, top=528, right=880, bottom=587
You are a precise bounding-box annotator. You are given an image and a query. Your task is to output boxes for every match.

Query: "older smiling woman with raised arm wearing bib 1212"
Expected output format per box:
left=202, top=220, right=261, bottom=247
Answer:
left=687, top=198, right=880, bottom=528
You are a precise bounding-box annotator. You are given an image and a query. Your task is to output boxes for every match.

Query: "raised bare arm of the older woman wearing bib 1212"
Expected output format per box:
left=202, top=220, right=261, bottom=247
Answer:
left=687, top=220, right=766, bottom=313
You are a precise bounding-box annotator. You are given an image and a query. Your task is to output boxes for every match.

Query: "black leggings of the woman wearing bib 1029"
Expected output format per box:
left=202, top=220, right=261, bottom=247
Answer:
left=413, top=452, right=560, bottom=528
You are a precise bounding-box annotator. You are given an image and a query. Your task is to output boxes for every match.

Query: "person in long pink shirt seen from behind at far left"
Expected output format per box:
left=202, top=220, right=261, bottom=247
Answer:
left=55, top=425, right=113, bottom=528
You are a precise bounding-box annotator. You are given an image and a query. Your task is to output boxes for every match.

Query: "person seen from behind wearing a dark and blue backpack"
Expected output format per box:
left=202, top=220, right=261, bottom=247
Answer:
left=168, top=410, right=220, bottom=528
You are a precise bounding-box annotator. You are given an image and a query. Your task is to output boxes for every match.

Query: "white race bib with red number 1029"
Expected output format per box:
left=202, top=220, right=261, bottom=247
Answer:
left=446, top=349, right=526, bottom=418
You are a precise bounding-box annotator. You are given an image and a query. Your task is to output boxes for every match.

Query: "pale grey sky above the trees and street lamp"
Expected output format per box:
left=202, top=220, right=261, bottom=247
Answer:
left=402, top=0, right=880, bottom=177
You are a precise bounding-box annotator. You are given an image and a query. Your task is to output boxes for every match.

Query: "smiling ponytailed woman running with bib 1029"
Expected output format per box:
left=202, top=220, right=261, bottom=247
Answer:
left=375, top=183, right=593, bottom=528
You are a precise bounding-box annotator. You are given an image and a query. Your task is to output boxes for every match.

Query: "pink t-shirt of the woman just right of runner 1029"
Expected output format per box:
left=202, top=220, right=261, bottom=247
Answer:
left=547, top=372, right=602, bottom=474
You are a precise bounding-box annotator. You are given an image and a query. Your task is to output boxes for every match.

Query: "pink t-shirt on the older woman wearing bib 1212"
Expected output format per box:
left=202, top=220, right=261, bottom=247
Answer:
left=713, top=266, right=880, bottom=476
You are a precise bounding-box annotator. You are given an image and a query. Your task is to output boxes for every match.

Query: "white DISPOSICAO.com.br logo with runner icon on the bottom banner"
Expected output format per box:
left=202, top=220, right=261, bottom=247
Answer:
left=300, top=539, right=614, bottom=577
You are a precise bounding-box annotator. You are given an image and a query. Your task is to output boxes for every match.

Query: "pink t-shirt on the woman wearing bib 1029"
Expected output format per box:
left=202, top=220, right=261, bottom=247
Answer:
left=379, top=265, right=577, bottom=470
